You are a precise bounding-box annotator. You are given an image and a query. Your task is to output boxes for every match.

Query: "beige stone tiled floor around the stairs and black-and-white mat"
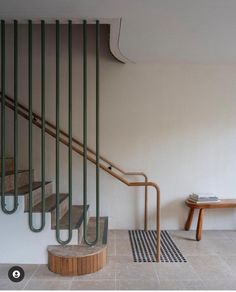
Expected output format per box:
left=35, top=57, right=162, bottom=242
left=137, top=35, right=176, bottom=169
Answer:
left=0, top=231, right=236, bottom=290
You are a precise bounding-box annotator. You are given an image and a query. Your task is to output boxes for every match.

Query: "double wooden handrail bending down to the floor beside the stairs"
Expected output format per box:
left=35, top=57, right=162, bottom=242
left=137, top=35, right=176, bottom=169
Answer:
left=0, top=92, right=160, bottom=262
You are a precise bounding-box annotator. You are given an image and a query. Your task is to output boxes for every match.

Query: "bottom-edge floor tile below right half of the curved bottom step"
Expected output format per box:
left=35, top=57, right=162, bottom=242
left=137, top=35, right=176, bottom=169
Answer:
left=70, top=280, right=116, bottom=290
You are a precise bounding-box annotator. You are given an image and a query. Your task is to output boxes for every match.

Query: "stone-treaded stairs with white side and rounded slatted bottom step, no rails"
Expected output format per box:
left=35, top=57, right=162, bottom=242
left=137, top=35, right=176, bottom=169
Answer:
left=0, top=158, right=108, bottom=275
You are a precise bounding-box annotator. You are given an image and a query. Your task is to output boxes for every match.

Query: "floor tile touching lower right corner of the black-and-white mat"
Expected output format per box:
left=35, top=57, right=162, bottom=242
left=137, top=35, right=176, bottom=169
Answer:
left=187, top=255, right=234, bottom=281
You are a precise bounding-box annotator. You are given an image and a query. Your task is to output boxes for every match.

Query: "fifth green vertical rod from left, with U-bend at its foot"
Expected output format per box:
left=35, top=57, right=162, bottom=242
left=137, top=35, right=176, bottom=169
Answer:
left=56, top=20, right=72, bottom=244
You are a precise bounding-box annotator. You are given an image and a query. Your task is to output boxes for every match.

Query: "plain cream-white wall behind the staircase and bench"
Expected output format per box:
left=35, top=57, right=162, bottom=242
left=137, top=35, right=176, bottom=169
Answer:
left=1, top=25, right=236, bottom=229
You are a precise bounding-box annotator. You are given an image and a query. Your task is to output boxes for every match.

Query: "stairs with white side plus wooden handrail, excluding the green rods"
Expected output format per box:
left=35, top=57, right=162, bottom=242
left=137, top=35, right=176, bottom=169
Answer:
left=0, top=93, right=160, bottom=266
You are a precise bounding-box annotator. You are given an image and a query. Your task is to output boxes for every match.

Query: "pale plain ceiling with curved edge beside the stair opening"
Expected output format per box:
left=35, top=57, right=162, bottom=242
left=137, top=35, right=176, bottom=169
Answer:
left=0, top=0, right=236, bottom=64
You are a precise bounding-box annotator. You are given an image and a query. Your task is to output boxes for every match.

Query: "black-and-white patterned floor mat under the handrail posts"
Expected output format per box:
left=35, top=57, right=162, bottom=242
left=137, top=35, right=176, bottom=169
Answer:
left=129, top=230, right=187, bottom=263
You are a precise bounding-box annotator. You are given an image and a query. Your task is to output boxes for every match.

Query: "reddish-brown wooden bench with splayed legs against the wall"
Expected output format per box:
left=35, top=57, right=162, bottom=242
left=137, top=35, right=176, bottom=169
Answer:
left=185, top=199, right=236, bottom=241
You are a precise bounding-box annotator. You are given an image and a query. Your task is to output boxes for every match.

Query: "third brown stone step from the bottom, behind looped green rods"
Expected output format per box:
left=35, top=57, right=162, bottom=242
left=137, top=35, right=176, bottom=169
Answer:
left=52, top=205, right=89, bottom=229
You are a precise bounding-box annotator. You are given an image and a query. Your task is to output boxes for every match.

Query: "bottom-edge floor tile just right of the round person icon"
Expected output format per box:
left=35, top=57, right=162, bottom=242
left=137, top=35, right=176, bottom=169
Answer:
left=24, top=279, right=71, bottom=290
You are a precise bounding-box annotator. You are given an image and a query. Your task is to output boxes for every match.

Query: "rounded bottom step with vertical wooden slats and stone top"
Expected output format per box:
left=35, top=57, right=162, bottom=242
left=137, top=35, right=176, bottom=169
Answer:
left=48, top=244, right=107, bottom=276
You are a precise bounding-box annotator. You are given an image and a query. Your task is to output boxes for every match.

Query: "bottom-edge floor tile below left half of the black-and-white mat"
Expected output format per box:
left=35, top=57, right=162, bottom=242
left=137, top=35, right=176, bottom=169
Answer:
left=116, top=280, right=160, bottom=290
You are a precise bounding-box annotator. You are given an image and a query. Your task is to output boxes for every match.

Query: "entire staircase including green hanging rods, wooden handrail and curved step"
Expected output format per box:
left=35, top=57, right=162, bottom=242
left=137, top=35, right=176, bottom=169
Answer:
left=0, top=20, right=160, bottom=275
